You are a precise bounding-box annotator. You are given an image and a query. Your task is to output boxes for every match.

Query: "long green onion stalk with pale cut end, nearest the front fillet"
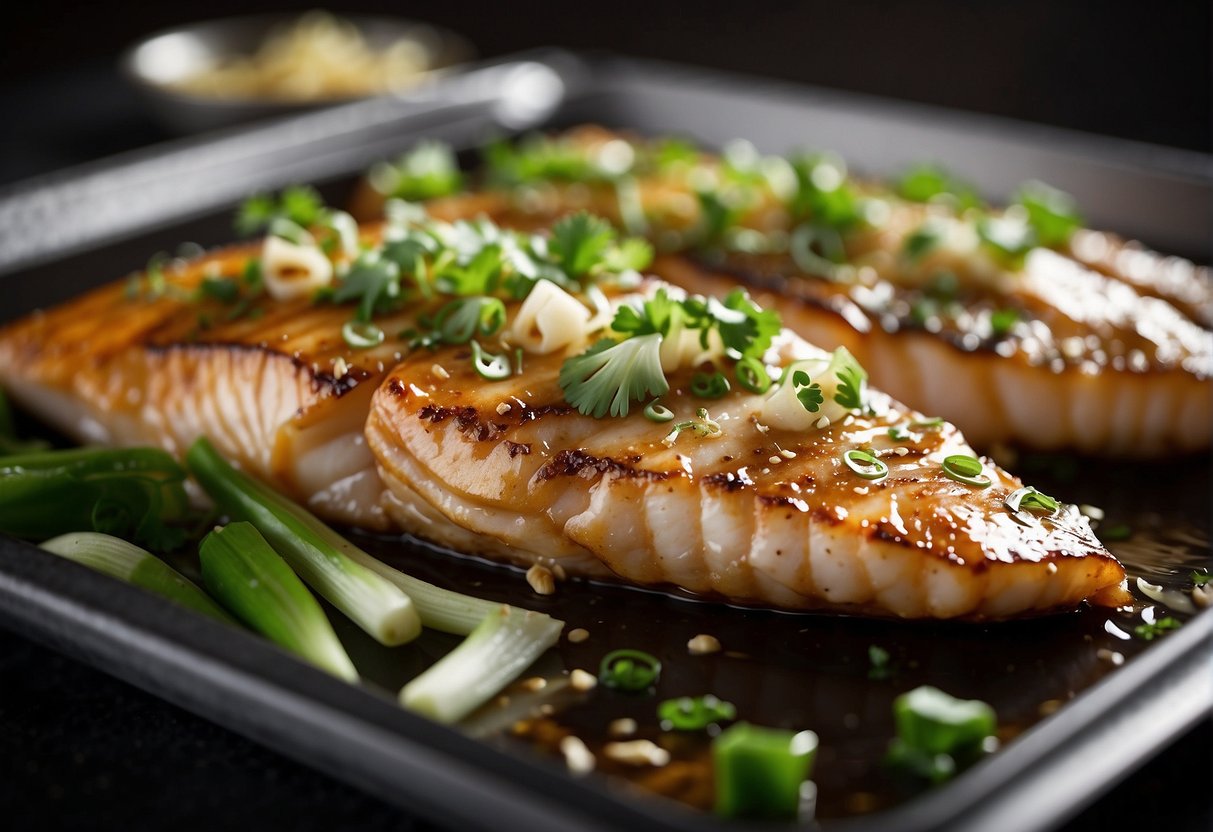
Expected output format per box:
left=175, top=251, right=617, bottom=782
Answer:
left=186, top=437, right=421, bottom=645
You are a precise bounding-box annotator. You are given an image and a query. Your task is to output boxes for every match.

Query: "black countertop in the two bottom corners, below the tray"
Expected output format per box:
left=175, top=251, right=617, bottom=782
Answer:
left=0, top=631, right=1213, bottom=832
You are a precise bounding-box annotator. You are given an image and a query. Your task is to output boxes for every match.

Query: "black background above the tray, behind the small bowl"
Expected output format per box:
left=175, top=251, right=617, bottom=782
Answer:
left=0, top=0, right=1213, bottom=182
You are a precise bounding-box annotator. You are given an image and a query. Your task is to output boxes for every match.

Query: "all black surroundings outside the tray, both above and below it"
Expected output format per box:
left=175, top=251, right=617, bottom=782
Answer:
left=0, top=0, right=1213, bottom=832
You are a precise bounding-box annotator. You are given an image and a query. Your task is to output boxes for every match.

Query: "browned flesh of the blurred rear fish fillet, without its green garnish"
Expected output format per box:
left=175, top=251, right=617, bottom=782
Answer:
left=357, top=127, right=1213, bottom=457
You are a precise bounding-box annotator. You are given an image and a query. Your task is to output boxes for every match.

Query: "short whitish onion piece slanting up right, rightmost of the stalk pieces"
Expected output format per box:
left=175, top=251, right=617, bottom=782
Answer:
left=400, top=605, right=564, bottom=724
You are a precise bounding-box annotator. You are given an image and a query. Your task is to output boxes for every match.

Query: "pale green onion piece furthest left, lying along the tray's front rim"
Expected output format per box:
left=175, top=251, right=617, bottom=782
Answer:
left=41, top=531, right=235, bottom=625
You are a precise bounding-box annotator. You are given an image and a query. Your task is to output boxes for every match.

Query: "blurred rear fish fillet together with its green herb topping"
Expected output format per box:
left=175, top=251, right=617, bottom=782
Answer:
left=358, top=127, right=1213, bottom=456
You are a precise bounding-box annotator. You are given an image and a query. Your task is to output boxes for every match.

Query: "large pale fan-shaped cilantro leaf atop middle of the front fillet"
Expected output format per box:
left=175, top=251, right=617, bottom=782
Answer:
left=559, top=332, right=670, bottom=418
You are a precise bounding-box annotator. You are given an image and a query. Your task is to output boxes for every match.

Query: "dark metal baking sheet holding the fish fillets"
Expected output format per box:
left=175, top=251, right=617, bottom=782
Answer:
left=0, top=52, right=1213, bottom=830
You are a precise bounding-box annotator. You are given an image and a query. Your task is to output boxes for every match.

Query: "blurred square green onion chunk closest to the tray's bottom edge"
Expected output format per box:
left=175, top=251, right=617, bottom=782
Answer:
left=712, top=722, right=818, bottom=820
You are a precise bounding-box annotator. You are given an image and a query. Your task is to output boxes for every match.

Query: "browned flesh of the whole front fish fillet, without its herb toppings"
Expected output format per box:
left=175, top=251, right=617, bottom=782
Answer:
left=0, top=232, right=1126, bottom=619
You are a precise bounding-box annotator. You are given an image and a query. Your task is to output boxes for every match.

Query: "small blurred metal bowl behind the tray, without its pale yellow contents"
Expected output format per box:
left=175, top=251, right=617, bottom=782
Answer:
left=121, top=13, right=474, bottom=133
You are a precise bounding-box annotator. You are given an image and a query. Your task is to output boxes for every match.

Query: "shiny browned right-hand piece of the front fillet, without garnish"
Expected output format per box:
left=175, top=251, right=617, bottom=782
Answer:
left=368, top=329, right=1123, bottom=617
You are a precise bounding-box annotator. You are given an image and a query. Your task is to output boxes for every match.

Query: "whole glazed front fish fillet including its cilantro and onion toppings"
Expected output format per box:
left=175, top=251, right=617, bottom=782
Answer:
left=0, top=206, right=1126, bottom=619
